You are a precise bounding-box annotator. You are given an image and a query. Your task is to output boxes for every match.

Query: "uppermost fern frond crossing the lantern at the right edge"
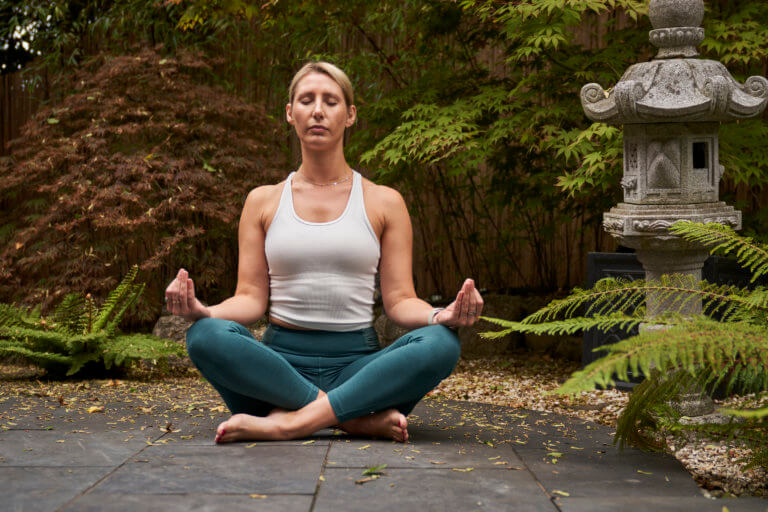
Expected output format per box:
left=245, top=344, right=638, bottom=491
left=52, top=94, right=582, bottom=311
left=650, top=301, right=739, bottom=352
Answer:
left=669, top=221, right=768, bottom=282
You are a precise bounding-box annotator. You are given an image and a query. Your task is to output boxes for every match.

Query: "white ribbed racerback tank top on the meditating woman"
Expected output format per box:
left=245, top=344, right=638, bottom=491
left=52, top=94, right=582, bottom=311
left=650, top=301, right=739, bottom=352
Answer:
left=264, top=171, right=381, bottom=331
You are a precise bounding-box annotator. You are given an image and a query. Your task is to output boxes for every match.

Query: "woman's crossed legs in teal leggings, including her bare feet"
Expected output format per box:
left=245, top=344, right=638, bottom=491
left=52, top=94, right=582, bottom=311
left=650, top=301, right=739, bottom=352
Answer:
left=187, top=319, right=459, bottom=443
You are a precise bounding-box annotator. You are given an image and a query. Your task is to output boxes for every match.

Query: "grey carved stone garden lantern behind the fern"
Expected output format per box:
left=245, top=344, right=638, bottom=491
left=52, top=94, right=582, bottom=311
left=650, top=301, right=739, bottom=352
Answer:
left=581, top=0, right=768, bottom=317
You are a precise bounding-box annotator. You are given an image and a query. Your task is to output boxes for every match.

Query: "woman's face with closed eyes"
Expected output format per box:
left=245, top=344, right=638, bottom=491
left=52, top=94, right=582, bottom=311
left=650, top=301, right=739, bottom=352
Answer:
left=286, top=73, right=356, bottom=149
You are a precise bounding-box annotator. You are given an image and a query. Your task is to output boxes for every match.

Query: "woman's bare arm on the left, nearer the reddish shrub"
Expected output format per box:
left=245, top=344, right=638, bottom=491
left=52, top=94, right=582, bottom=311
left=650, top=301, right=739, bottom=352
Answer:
left=165, top=186, right=274, bottom=325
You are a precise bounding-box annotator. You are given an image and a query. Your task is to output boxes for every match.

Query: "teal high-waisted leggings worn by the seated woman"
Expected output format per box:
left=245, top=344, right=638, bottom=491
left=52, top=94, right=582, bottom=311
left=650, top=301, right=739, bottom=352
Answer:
left=187, top=318, right=460, bottom=422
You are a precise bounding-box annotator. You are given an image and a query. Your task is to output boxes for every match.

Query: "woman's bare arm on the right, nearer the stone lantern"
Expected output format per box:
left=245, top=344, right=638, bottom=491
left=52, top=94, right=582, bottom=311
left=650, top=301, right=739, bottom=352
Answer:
left=372, top=186, right=483, bottom=329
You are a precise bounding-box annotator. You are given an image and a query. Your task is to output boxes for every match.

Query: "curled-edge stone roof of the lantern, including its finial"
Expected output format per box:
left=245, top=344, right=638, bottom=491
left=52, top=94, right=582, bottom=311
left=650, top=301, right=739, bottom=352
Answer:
left=581, top=0, right=768, bottom=124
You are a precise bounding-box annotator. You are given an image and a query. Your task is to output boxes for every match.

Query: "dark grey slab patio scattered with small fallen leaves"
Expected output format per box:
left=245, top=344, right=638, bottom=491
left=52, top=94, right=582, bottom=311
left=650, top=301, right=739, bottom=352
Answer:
left=0, top=399, right=768, bottom=512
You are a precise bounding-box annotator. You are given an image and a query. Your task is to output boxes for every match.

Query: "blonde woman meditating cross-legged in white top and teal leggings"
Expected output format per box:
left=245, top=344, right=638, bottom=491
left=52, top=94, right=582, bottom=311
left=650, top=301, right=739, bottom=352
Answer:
left=165, top=62, right=483, bottom=443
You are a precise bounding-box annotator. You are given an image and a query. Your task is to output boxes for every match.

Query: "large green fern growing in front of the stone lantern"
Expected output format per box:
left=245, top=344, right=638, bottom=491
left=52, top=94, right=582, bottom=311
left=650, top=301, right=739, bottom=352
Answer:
left=483, top=222, right=768, bottom=466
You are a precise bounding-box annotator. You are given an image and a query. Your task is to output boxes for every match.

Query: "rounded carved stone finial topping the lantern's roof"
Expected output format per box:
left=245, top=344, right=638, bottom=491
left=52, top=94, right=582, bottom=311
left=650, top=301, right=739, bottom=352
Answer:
left=648, top=0, right=704, bottom=59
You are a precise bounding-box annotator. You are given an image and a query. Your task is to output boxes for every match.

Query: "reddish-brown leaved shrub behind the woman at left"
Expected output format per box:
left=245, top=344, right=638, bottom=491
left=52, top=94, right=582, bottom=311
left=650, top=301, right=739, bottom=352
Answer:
left=0, top=49, right=287, bottom=324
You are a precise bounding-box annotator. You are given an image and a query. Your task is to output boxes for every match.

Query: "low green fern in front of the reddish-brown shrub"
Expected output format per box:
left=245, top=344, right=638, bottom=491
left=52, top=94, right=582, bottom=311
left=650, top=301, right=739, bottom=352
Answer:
left=0, top=266, right=183, bottom=376
